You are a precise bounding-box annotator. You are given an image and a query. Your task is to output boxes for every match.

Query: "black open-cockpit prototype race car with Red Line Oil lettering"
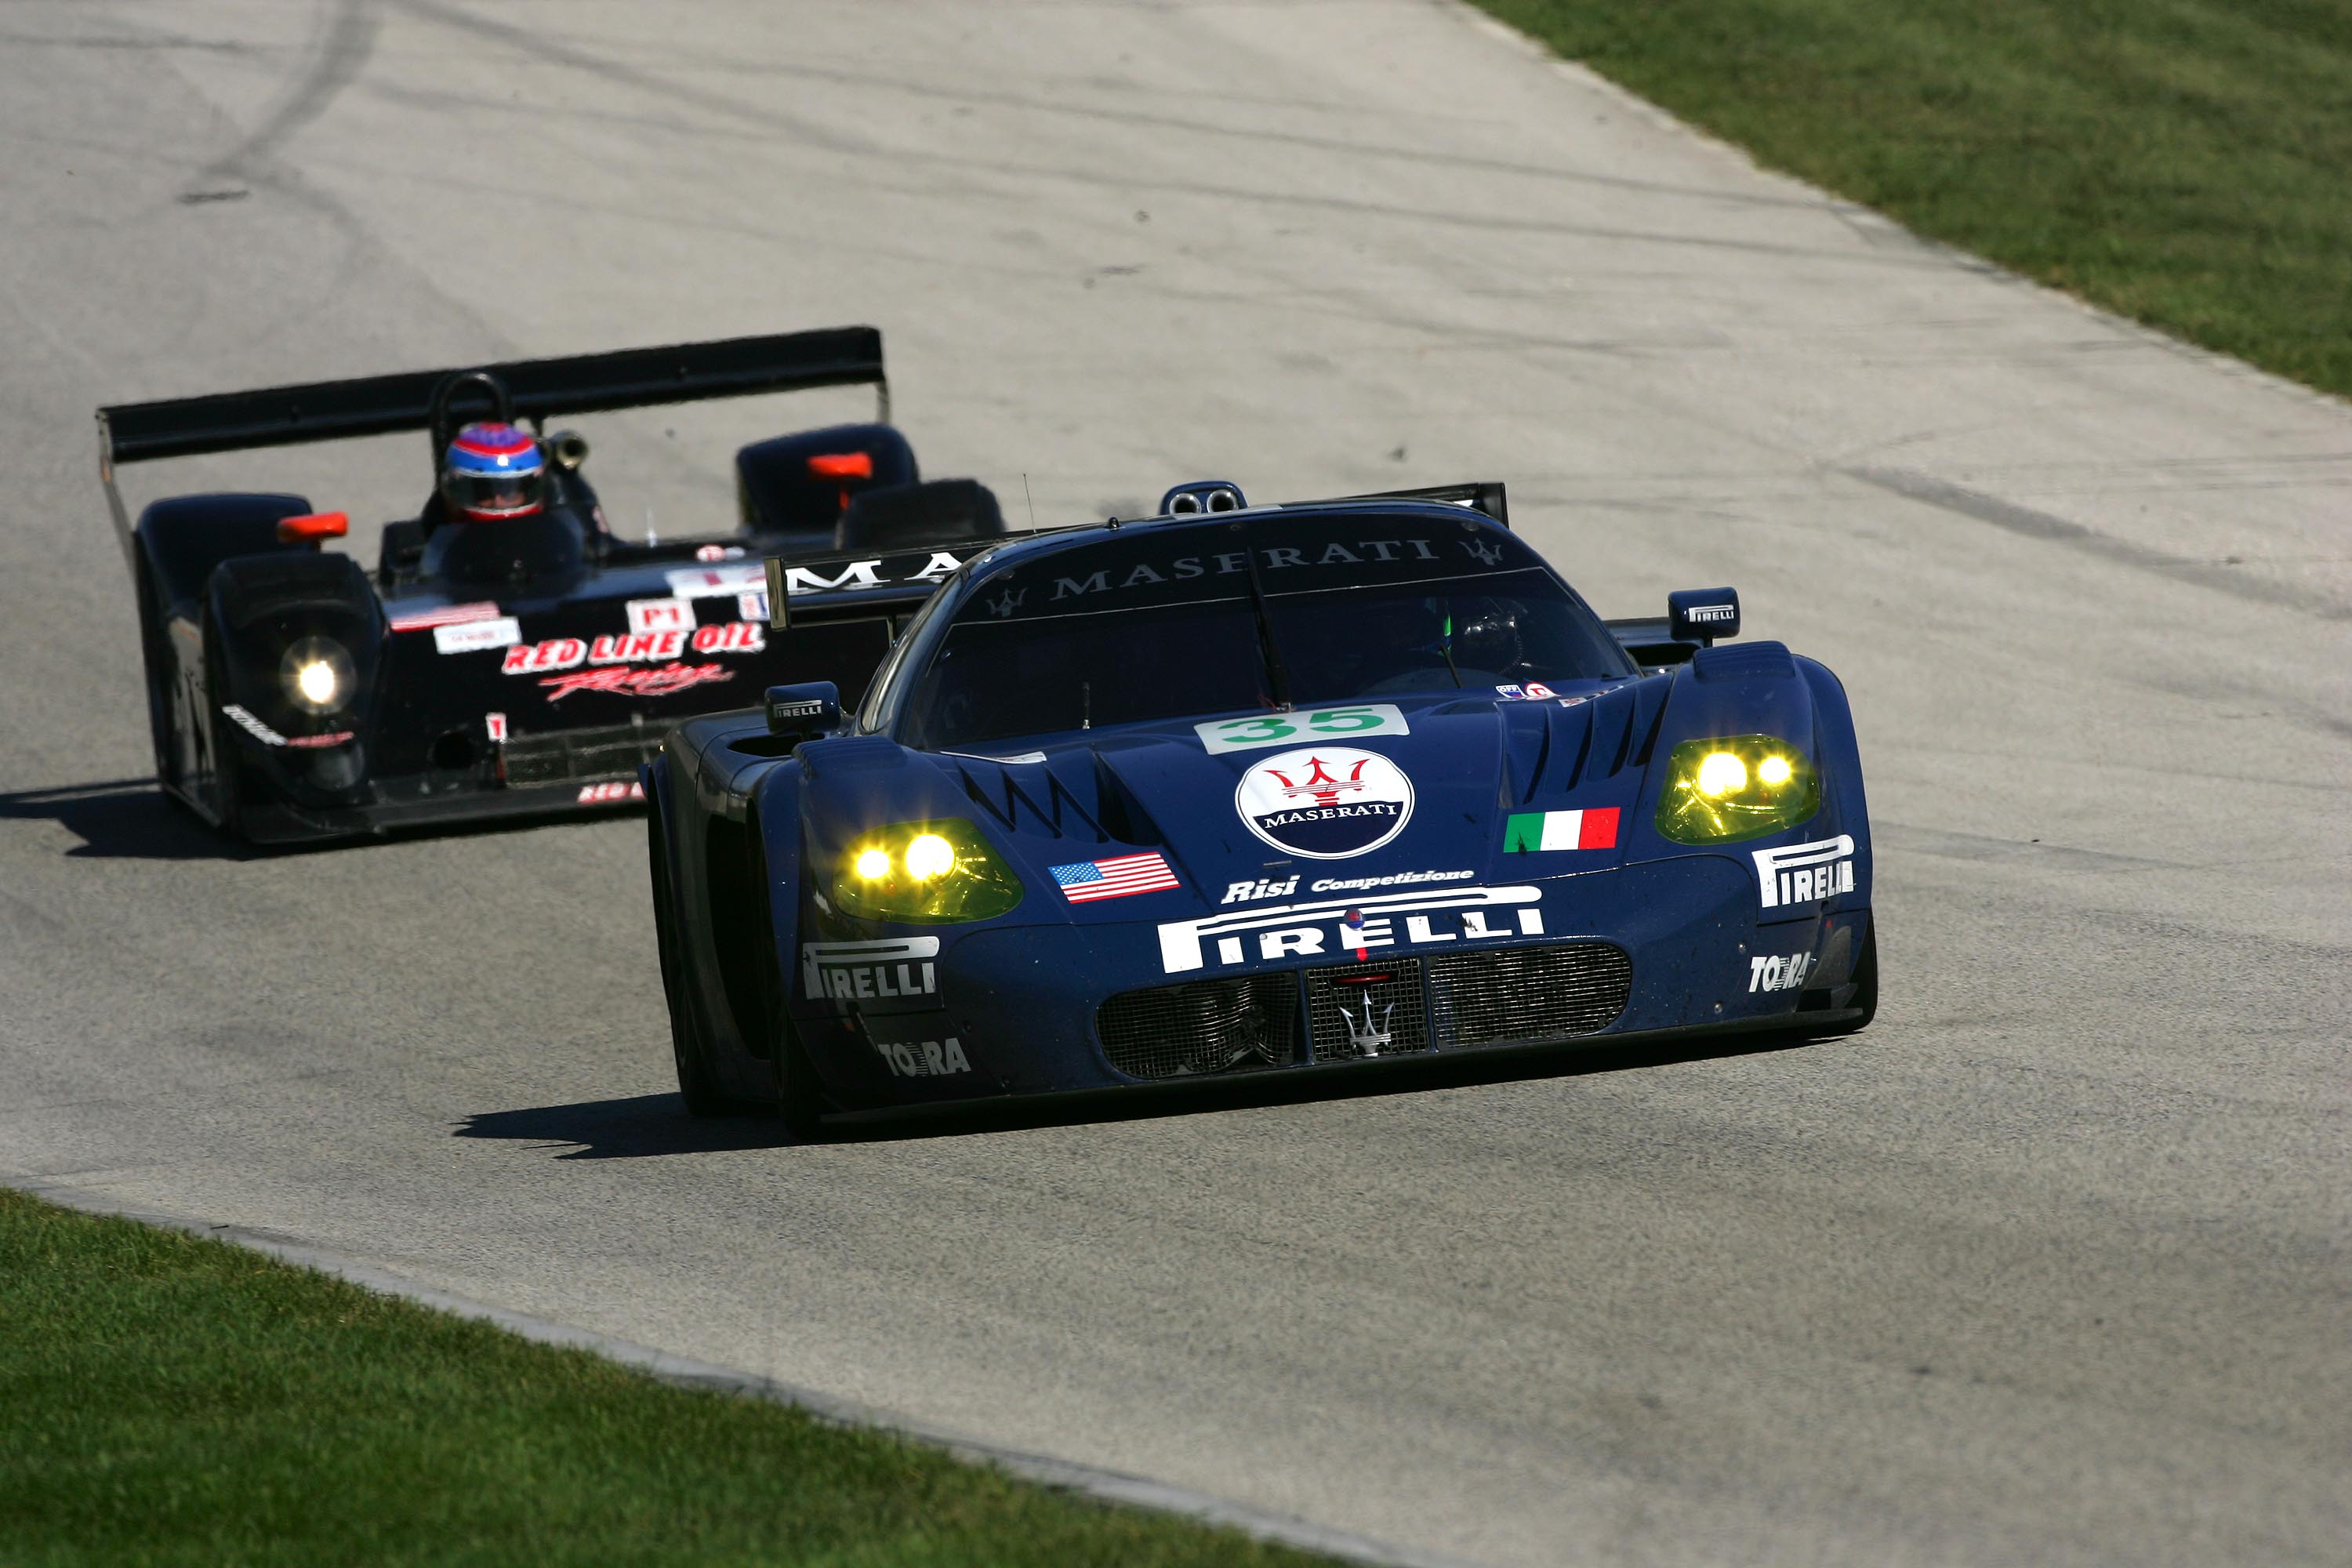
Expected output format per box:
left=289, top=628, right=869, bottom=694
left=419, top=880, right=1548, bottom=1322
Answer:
left=99, top=327, right=1002, bottom=841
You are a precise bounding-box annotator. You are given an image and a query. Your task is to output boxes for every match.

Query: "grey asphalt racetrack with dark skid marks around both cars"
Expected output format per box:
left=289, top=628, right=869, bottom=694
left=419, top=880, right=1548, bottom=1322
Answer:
left=0, top=0, right=2352, bottom=1566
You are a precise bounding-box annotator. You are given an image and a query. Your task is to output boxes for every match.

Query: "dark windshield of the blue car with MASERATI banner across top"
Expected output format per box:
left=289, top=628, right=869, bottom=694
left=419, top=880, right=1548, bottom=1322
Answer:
left=906, top=515, right=1632, bottom=750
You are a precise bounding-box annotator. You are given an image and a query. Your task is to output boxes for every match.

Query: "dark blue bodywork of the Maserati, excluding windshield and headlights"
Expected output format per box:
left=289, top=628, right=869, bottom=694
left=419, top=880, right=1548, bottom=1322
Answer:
left=644, top=503, right=1877, bottom=1114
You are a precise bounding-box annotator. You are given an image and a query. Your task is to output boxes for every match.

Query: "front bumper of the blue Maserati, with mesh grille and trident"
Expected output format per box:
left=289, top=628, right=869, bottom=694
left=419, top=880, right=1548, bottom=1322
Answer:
left=795, top=855, right=1870, bottom=1112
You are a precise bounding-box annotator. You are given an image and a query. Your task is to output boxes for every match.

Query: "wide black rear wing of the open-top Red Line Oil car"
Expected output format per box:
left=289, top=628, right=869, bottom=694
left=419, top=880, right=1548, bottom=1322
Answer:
left=99, top=327, right=889, bottom=573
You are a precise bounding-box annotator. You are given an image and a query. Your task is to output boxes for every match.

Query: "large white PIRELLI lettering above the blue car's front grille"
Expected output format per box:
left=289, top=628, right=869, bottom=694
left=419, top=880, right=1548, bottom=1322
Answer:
left=1160, top=886, right=1543, bottom=975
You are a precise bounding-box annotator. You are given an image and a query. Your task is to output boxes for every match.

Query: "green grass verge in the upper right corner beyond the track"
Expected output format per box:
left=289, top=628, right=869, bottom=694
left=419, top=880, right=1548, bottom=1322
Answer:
left=1479, top=0, right=2352, bottom=395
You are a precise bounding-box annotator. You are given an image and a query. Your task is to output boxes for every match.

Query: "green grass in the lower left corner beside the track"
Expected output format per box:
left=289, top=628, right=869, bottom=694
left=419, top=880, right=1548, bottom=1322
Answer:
left=0, top=1189, right=1322, bottom=1568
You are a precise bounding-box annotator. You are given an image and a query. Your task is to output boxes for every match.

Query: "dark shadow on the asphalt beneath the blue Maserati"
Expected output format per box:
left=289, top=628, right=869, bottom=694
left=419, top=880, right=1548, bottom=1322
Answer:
left=454, top=1034, right=1837, bottom=1159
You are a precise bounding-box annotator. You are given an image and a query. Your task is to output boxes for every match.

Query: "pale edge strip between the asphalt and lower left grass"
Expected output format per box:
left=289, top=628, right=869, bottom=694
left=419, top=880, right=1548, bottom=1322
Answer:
left=18, top=1175, right=1477, bottom=1568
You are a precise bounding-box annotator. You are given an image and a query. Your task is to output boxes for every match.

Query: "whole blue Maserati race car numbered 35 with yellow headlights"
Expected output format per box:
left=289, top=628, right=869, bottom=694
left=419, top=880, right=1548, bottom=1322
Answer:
left=642, top=482, right=1877, bottom=1131
